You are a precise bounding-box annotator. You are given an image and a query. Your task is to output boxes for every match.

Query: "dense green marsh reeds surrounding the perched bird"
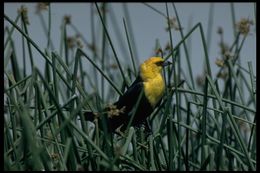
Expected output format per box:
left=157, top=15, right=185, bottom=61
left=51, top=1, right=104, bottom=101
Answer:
left=3, top=3, right=256, bottom=171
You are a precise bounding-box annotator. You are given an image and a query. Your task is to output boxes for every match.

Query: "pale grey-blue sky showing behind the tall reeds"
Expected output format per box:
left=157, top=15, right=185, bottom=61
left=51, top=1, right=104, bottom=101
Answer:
left=4, top=3, right=256, bottom=89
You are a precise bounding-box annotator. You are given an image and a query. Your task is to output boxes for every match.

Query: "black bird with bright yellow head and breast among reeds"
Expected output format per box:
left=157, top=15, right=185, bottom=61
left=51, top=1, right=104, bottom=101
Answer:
left=84, top=57, right=172, bottom=132
